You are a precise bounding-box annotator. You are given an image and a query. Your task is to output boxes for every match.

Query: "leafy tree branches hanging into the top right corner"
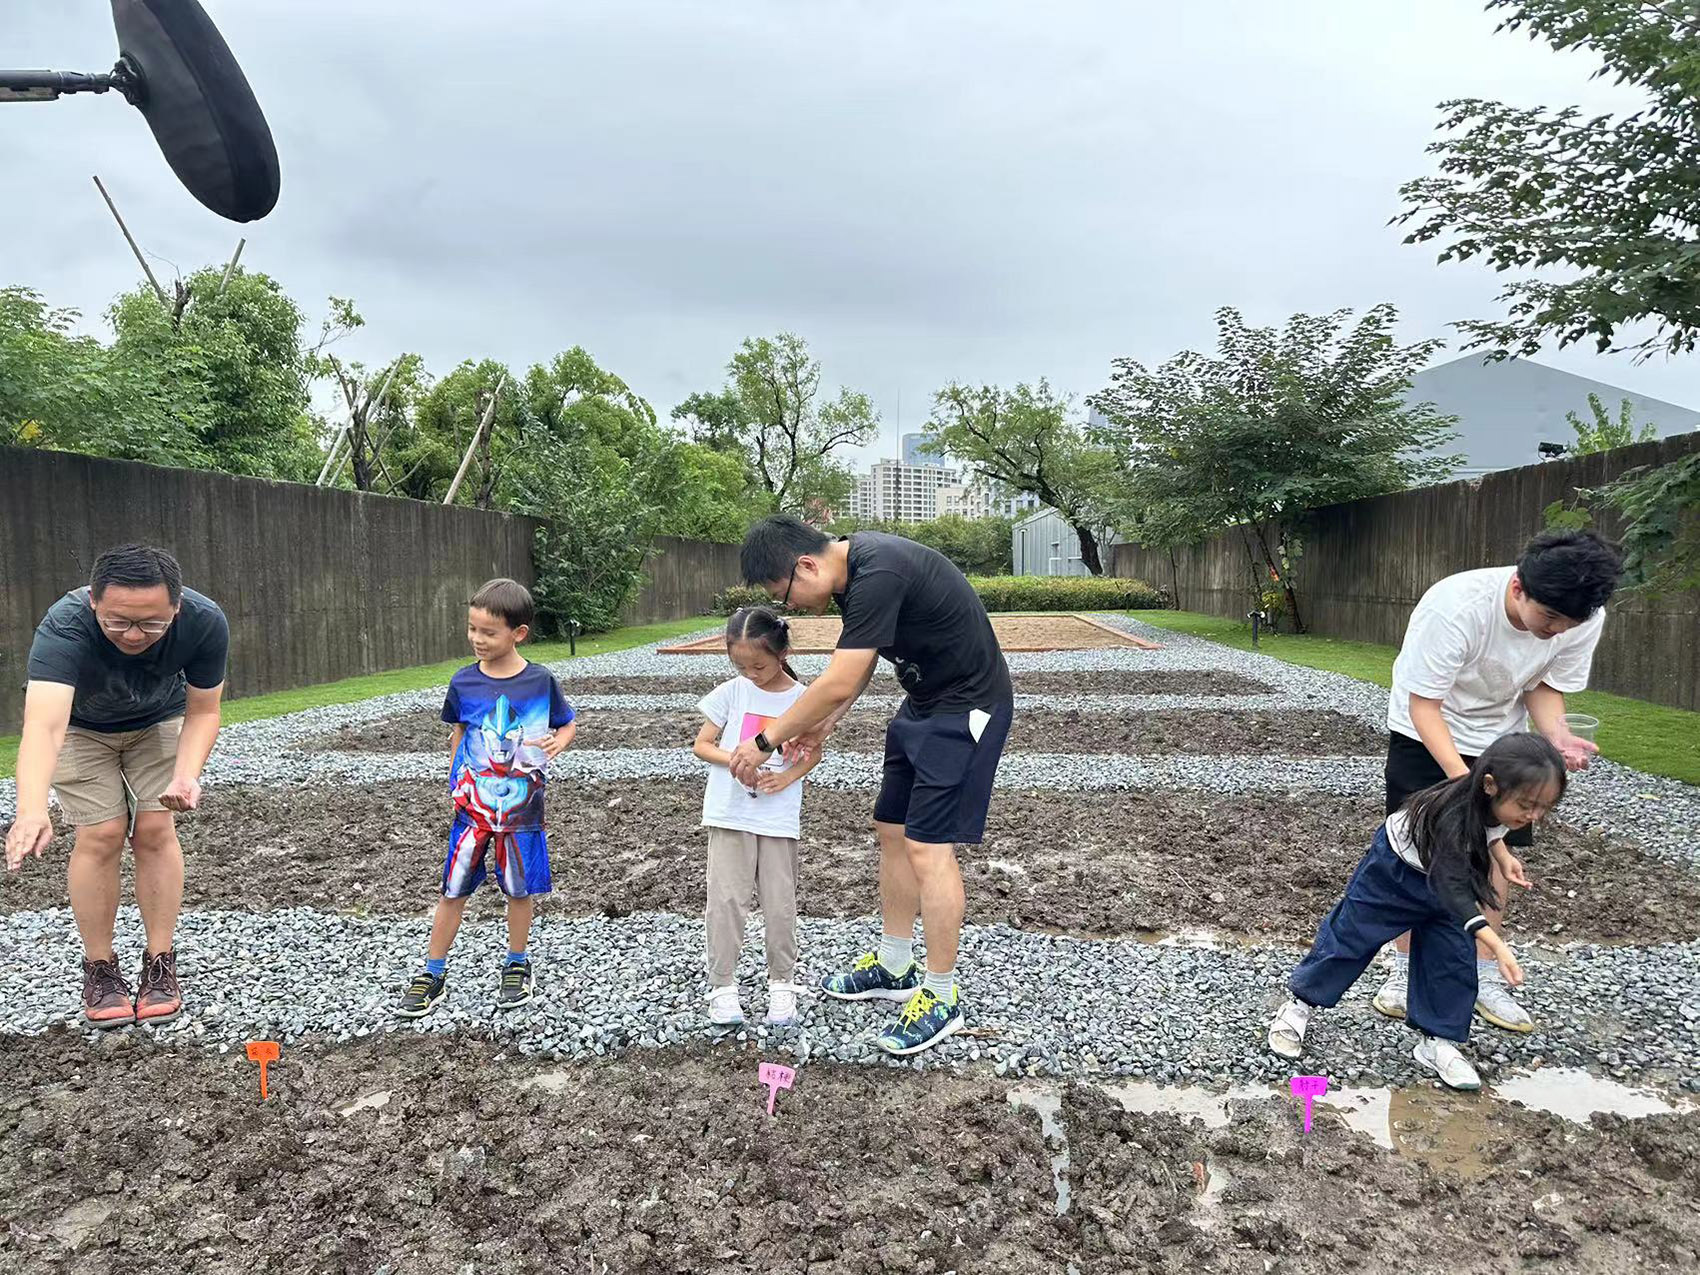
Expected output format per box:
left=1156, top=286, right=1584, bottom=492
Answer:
left=1396, top=0, right=1700, bottom=357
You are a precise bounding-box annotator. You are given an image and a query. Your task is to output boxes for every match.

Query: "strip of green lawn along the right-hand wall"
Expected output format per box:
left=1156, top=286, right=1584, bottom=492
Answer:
left=1127, top=610, right=1700, bottom=784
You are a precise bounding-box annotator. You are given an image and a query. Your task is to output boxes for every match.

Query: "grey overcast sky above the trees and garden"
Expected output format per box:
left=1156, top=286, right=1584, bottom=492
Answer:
left=0, top=0, right=1700, bottom=469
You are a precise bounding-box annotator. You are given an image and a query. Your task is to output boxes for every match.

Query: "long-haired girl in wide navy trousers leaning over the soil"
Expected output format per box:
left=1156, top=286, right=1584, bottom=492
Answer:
left=1268, top=734, right=1566, bottom=1090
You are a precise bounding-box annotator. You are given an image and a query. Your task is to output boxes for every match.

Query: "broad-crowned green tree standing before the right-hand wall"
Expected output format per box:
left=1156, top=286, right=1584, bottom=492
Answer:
left=1091, top=304, right=1457, bottom=632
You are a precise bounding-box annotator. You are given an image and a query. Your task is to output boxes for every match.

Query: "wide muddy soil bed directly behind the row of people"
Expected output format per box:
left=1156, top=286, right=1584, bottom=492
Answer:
left=0, top=780, right=1700, bottom=944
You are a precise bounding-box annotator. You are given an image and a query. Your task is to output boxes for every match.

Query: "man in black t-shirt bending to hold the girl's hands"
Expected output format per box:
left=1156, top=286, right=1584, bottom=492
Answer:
left=731, top=513, right=1015, bottom=1054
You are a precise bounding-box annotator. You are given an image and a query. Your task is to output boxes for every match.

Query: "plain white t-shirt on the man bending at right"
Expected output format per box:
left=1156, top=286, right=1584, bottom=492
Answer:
left=1387, top=566, right=1605, bottom=757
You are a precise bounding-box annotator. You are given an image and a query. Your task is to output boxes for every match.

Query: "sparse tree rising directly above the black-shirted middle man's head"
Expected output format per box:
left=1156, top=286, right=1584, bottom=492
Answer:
left=686, top=332, right=879, bottom=512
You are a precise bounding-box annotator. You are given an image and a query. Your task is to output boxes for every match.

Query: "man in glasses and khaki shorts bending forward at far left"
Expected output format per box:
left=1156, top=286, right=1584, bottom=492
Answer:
left=5, top=544, right=230, bottom=1027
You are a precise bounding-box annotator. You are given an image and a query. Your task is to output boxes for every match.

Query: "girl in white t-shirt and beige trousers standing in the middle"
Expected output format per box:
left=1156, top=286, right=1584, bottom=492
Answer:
left=692, top=607, right=819, bottom=1027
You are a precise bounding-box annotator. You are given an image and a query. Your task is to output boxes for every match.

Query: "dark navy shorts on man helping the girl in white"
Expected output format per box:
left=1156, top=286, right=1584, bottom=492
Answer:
left=874, top=694, right=1015, bottom=845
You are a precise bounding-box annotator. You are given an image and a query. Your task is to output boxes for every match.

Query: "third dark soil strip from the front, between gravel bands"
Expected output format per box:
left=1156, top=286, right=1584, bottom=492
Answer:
left=316, top=707, right=1387, bottom=757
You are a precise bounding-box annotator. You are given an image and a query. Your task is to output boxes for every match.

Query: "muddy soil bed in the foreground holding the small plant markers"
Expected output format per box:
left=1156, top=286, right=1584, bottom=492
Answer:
left=0, top=1032, right=1700, bottom=1275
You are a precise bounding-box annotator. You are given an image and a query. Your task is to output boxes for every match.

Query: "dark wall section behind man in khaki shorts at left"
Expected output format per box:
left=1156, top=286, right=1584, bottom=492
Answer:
left=0, top=447, right=532, bottom=733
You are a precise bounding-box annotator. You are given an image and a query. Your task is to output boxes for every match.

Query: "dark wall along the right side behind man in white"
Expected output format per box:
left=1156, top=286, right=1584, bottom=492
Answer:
left=1112, top=434, right=1700, bottom=709
